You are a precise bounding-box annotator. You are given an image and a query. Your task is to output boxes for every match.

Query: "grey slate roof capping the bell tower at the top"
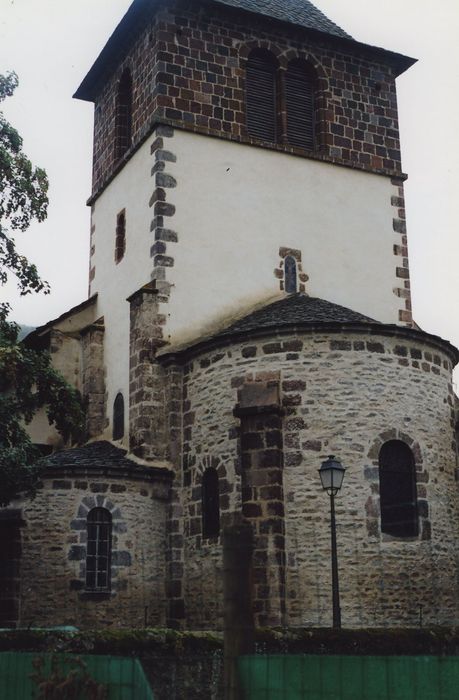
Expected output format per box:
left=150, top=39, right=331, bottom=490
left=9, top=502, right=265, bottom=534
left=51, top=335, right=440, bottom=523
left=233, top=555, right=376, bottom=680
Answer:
left=214, top=0, right=352, bottom=39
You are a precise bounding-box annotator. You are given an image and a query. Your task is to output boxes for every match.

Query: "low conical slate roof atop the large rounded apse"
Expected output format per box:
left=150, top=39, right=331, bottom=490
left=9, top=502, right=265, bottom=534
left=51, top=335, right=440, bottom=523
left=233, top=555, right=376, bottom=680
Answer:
left=214, top=292, right=379, bottom=338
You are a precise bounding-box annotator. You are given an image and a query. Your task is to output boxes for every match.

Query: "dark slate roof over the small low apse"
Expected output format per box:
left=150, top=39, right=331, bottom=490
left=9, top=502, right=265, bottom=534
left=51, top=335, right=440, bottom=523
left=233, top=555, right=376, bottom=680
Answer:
left=42, top=440, right=170, bottom=476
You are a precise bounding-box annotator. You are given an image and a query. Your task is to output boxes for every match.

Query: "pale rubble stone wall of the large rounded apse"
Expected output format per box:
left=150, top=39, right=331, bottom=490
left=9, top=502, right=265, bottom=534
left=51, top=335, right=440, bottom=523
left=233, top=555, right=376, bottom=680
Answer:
left=168, top=332, right=459, bottom=627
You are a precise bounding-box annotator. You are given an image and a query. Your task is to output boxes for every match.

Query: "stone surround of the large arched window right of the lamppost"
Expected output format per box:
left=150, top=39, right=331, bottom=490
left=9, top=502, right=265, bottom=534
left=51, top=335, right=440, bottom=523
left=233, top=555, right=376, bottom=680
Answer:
left=364, top=429, right=431, bottom=542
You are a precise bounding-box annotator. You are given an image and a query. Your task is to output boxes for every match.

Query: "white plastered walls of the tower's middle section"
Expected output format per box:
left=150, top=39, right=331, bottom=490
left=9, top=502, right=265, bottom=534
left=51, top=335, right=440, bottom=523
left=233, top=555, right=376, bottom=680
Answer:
left=91, top=129, right=406, bottom=437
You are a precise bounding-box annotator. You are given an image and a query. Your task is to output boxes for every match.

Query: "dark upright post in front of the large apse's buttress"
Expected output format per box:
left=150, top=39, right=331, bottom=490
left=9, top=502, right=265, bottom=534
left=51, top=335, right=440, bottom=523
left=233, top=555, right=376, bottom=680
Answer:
left=223, top=523, right=254, bottom=700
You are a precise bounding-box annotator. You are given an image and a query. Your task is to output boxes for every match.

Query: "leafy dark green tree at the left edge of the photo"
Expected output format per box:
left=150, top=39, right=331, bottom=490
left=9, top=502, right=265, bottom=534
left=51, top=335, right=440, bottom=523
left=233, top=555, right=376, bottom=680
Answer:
left=0, top=73, right=84, bottom=506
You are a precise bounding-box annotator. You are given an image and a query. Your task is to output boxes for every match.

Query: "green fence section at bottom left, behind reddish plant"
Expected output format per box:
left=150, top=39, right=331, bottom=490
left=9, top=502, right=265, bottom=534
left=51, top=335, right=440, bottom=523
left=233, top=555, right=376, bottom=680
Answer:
left=0, top=651, right=153, bottom=700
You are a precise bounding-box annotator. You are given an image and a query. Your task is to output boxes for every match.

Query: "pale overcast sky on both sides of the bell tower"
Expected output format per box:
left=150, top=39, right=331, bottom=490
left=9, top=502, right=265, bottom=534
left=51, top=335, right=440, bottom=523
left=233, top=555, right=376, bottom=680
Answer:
left=0, top=0, right=459, bottom=380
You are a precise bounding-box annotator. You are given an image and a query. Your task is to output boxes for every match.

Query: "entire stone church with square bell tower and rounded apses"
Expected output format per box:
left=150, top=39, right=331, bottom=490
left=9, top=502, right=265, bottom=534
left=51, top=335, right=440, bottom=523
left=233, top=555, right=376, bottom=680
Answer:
left=0, top=0, right=459, bottom=629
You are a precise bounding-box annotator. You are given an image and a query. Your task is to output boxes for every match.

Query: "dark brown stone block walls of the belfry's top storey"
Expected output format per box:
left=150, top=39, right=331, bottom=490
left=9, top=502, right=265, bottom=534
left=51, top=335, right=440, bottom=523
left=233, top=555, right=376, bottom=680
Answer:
left=88, top=0, right=401, bottom=195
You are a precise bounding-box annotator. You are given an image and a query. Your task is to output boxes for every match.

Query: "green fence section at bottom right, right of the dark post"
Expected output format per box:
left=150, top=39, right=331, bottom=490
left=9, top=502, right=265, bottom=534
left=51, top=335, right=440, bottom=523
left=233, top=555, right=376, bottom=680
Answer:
left=239, top=654, right=459, bottom=700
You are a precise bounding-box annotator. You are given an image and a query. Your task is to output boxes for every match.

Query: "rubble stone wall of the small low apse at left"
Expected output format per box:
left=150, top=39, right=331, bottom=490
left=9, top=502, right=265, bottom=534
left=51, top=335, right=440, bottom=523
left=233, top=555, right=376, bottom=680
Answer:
left=19, top=474, right=168, bottom=629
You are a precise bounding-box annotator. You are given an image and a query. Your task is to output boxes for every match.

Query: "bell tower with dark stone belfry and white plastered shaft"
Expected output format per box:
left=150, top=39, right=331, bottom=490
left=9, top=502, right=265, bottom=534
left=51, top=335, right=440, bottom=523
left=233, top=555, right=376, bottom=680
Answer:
left=75, top=0, right=414, bottom=442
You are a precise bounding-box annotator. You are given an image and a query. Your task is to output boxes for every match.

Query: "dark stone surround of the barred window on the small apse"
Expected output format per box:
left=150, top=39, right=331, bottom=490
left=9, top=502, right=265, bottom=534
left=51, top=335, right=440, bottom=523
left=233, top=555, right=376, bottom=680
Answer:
left=67, top=495, right=131, bottom=601
